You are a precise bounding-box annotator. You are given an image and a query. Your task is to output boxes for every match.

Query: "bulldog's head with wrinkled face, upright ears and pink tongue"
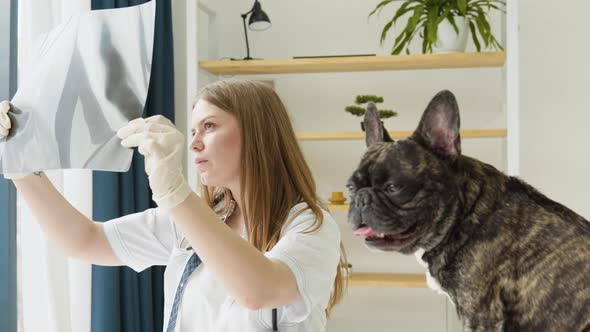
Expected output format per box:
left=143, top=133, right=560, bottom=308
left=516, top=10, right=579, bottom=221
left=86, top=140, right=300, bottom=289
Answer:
left=347, top=91, right=461, bottom=254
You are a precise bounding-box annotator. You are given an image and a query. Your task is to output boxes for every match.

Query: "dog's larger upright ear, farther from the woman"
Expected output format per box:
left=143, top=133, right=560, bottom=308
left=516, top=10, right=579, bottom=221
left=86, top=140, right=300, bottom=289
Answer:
left=412, top=90, right=461, bottom=157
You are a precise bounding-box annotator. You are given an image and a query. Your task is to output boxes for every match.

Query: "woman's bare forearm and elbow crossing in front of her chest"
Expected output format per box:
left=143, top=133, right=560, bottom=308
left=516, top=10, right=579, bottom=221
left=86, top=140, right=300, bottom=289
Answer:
left=170, top=193, right=300, bottom=310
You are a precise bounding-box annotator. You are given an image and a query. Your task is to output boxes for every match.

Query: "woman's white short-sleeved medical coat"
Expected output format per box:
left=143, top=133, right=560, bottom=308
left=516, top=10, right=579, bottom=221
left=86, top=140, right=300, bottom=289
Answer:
left=104, top=203, right=340, bottom=332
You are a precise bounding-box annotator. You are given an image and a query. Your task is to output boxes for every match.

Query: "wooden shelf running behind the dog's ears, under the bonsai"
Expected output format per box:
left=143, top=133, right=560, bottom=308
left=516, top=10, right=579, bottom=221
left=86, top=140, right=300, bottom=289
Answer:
left=297, top=129, right=508, bottom=141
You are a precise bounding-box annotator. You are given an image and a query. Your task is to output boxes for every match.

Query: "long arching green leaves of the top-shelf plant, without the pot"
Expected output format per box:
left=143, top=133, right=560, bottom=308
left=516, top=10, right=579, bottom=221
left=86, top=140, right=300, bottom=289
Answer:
left=369, top=0, right=506, bottom=54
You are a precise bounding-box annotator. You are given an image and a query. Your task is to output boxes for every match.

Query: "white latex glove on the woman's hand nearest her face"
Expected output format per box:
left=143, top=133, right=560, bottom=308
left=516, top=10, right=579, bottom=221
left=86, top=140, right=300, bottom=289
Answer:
left=117, top=115, right=192, bottom=209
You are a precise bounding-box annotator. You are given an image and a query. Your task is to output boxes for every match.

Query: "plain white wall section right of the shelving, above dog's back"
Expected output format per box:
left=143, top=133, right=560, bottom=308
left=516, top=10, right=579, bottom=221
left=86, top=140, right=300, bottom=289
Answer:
left=520, top=0, right=590, bottom=219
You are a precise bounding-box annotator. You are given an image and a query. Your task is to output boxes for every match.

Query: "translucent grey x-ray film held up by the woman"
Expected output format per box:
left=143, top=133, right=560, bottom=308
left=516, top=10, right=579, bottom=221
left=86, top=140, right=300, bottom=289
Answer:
left=0, top=1, right=155, bottom=173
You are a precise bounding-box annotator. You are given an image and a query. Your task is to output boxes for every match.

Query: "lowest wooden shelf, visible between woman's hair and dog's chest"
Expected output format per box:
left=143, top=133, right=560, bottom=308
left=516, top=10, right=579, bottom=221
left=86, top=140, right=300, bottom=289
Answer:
left=348, top=272, right=428, bottom=288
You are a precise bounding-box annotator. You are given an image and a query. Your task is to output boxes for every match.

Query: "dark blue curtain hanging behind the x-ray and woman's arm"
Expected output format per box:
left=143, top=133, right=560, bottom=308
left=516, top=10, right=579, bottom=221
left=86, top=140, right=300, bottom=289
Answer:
left=92, top=0, right=174, bottom=332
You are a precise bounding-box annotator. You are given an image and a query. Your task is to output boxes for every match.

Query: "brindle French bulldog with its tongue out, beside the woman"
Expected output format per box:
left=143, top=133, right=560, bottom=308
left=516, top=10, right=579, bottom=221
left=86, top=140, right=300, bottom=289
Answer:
left=348, top=91, right=590, bottom=332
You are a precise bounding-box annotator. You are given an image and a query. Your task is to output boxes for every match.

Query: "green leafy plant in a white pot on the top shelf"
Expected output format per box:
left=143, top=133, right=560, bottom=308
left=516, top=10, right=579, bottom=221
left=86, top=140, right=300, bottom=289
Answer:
left=369, top=0, right=506, bottom=55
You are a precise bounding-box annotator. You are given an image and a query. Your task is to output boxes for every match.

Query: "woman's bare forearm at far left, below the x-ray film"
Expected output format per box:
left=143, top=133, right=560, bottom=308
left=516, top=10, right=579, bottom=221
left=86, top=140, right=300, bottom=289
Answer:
left=13, top=172, right=123, bottom=266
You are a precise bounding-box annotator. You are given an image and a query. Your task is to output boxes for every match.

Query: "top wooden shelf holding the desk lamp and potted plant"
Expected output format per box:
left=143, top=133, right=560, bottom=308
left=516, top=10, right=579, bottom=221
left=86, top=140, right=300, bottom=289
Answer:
left=199, top=52, right=506, bottom=75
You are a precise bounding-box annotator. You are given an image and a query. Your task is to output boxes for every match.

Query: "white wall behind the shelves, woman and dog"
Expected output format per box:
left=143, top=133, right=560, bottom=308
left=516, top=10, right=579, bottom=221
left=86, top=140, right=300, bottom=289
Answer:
left=177, top=0, right=590, bottom=331
